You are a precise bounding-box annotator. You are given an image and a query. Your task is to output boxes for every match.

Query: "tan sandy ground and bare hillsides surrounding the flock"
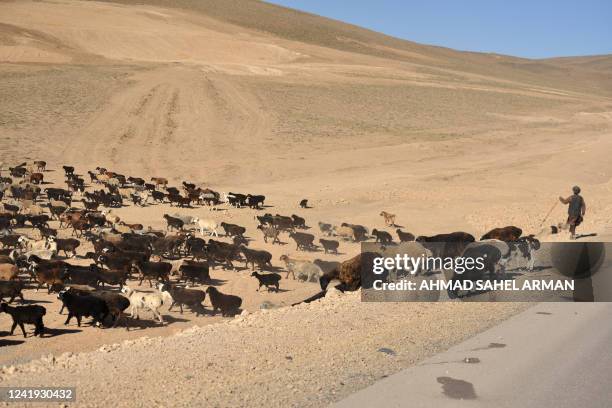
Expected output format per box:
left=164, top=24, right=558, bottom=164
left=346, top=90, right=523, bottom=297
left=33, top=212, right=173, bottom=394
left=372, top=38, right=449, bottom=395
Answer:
left=0, top=0, right=612, bottom=406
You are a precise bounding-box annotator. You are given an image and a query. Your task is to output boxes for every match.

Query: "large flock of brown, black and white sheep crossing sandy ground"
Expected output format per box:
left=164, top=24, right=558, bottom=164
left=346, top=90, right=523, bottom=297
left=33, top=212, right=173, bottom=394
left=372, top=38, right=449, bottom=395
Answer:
left=0, top=161, right=544, bottom=337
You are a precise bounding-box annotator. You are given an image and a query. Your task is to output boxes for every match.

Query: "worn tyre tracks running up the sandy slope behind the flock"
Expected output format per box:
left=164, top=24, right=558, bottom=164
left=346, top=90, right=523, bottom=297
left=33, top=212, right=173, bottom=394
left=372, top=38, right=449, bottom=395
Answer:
left=56, top=67, right=272, bottom=181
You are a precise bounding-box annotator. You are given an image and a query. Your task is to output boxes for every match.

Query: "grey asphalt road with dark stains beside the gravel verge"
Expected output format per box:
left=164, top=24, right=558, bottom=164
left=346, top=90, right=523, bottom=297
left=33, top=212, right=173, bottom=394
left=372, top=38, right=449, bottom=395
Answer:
left=334, top=303, right=612, bottom=408
